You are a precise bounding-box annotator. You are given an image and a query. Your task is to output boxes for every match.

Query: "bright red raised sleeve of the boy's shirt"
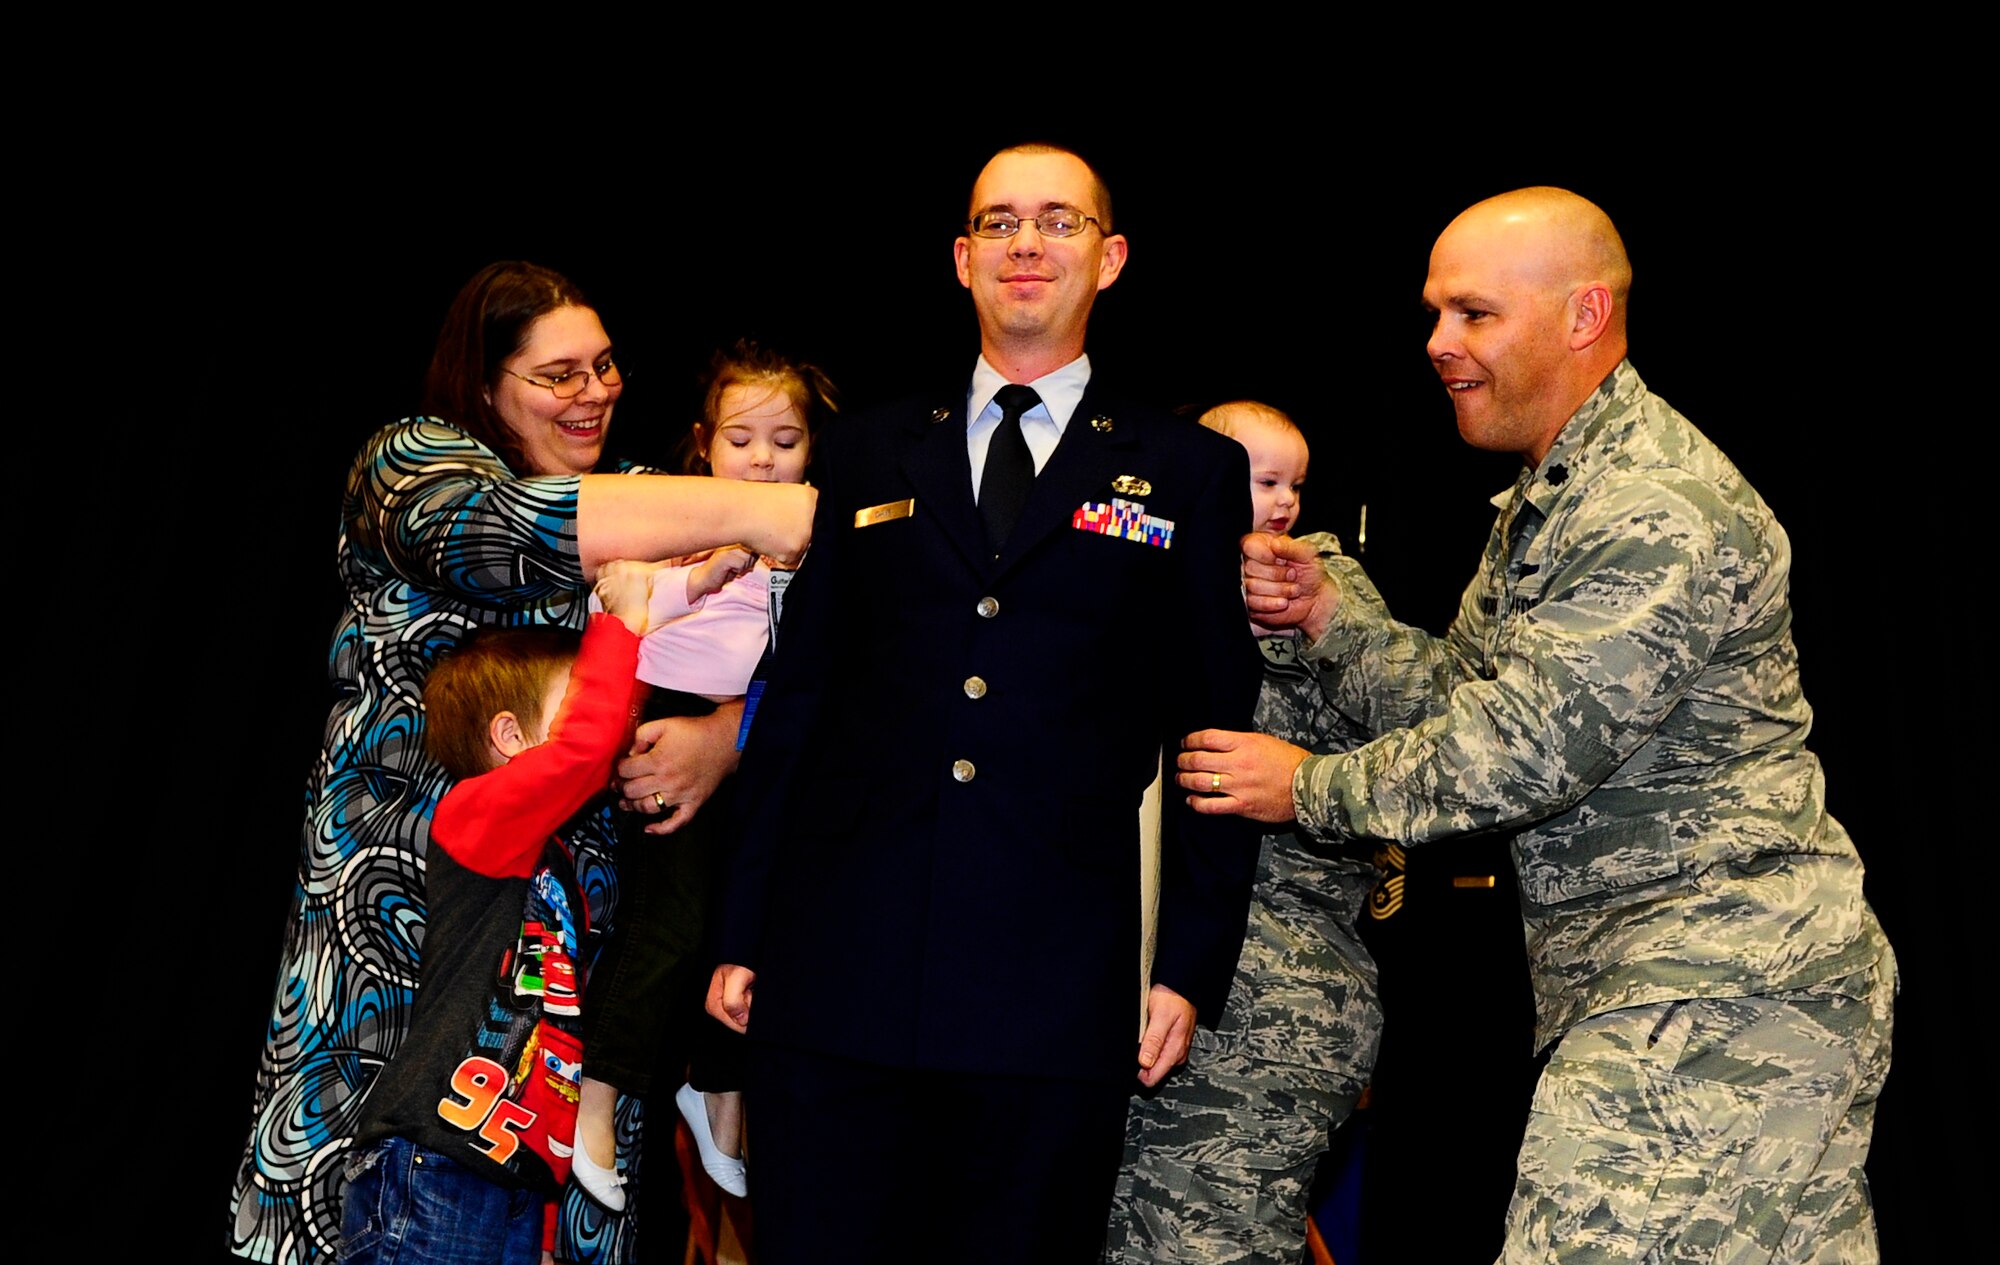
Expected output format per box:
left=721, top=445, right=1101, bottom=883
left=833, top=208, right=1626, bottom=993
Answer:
left=430, top=614, right=638, bottom=879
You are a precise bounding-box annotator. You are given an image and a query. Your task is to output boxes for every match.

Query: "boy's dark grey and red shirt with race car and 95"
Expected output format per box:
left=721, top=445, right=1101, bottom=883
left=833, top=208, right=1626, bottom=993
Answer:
left=358, top=614, right=638, bottom=1191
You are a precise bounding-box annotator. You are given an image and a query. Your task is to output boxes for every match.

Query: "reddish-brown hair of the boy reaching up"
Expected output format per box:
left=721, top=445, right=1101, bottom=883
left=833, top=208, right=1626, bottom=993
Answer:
left=424, top=628, right=584, bottom=779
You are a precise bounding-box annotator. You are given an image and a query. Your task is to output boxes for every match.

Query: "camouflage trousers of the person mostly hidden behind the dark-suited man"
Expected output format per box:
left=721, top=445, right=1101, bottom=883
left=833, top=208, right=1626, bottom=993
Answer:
left=1104, top=1027, right=1380, bottom=1265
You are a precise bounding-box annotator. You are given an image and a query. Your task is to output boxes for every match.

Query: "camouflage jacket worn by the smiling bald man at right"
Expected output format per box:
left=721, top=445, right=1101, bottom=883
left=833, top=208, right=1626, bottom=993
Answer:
left=1292, top=360, right=1884, bottom=1049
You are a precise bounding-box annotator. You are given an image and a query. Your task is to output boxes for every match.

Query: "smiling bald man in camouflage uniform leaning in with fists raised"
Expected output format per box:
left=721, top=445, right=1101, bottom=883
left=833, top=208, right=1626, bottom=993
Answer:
left=1178, top=188, right=1896, bottom=1265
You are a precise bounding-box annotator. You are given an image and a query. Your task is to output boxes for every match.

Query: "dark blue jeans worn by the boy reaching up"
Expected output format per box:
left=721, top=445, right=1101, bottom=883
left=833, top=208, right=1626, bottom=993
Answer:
left=340, top=1137, right=548, bottom=1265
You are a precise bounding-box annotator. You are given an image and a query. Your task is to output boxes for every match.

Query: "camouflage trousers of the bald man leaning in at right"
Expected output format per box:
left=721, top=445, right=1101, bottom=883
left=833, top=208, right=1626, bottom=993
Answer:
left=1500, top=945, right=1896, bottom=1265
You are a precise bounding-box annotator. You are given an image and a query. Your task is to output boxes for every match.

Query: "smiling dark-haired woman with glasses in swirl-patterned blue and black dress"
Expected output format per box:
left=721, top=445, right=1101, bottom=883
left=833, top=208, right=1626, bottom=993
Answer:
left=230, top=262, right=812, bottom=1263
